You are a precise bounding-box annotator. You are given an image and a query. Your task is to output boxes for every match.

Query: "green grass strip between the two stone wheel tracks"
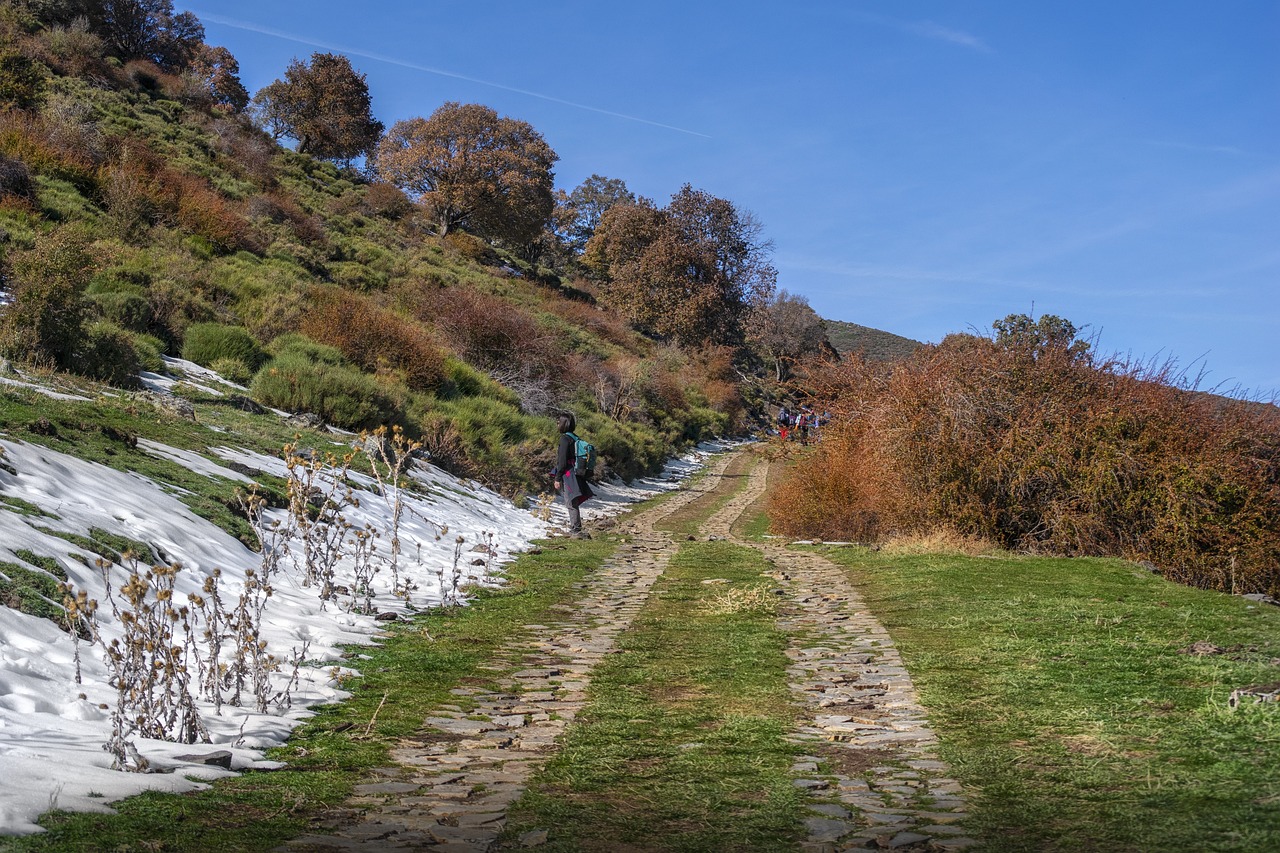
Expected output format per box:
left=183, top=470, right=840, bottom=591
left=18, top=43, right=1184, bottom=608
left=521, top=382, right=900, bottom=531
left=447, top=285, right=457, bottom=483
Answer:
left=496, top=542, right=804, bottom=850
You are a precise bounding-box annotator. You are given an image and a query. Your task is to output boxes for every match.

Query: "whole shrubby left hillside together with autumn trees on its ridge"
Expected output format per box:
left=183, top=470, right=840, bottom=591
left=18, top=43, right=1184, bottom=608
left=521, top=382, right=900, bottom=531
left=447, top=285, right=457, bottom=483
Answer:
left=0, top=0, right=839, bottom=496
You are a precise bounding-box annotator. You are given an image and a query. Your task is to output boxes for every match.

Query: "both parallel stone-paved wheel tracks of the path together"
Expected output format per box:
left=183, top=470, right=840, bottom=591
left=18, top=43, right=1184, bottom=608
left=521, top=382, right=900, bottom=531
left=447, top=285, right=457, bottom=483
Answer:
left=280, top=455, right=977, bottom=853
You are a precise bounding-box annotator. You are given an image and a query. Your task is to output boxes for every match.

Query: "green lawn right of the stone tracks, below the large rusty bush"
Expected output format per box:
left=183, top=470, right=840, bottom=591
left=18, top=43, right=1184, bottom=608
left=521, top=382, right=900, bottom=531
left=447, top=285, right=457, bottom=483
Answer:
left=828, top=548, right=1280, bottom=850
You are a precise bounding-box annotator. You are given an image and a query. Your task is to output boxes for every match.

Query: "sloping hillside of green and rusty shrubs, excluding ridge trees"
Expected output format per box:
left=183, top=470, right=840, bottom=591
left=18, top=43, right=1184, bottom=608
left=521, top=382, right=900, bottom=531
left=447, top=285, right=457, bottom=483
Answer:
left=0, top=48, right=760, bottom=496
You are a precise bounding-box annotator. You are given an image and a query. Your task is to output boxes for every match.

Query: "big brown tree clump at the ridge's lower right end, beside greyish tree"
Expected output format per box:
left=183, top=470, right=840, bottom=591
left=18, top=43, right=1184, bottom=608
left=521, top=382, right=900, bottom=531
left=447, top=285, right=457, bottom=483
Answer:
left=584, top=184, right=777, bottom=346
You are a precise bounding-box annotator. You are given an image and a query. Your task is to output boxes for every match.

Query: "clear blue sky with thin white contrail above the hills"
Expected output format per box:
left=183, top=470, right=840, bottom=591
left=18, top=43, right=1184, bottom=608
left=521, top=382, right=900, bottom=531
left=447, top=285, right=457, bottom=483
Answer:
left=192, top=0, right=1280, bottom=397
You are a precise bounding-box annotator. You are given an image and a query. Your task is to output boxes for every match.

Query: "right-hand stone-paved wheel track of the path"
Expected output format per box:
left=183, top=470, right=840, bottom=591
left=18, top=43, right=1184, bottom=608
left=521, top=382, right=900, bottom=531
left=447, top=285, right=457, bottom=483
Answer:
left=703, top=450, right=977, bottom=853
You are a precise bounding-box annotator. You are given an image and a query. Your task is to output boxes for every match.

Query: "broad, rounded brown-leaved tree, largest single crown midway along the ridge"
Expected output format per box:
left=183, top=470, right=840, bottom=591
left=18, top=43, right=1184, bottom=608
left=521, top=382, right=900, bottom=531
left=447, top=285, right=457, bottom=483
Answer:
left=375, top=101, right=559, bottom=247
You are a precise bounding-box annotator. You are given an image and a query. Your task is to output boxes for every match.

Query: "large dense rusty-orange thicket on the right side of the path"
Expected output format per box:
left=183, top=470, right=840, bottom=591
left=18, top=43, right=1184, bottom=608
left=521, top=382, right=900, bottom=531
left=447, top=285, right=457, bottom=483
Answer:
left=773, top=336, right=1280, bottom=593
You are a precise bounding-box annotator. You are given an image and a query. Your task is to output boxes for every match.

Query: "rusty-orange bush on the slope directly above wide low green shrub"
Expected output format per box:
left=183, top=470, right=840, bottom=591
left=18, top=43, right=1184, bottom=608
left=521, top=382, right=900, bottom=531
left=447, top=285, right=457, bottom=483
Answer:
left=300, top=287, right=445, bottom=391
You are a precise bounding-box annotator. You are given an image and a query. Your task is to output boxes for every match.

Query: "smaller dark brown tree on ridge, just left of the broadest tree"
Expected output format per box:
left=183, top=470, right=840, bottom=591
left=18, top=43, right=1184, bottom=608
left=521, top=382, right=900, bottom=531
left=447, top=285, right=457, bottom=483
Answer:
left=253, top=54, right=383, bottom=161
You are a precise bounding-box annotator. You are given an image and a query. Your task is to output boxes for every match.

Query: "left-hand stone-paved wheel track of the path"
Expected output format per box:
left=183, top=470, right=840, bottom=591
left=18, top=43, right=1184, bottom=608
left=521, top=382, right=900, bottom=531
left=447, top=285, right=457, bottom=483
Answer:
left=280, top=455, right=733, bottom=853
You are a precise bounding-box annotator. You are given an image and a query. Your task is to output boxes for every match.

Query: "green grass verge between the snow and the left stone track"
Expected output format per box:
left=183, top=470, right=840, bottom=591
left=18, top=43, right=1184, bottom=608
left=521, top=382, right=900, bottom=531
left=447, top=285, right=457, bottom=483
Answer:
left=0, top=539, right=614, bottom=853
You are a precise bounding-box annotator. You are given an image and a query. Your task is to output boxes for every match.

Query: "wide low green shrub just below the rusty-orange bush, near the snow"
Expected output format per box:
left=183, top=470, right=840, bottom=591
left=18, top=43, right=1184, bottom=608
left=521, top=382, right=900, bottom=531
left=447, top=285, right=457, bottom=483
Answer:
left=251, top=352, right=404, bottom=429
